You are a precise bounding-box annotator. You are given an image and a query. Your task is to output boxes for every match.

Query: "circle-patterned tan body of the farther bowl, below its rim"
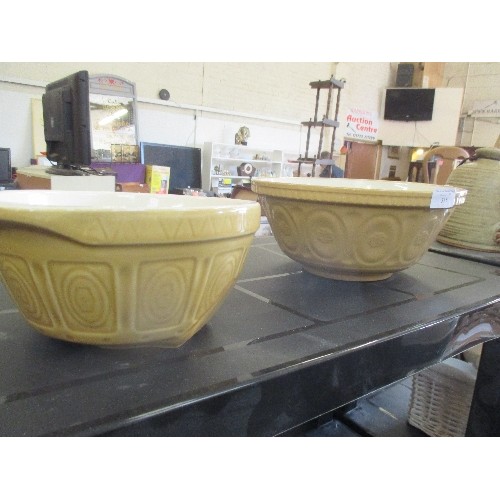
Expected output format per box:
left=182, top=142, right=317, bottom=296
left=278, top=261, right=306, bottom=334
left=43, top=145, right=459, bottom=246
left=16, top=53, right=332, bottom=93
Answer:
left=260, top=196, right=443, bottom=276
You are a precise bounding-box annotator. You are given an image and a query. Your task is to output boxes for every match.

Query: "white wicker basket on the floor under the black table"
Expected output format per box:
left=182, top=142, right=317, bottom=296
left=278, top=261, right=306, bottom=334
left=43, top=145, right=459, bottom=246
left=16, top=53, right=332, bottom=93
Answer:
left=408, top=358, right=477, bottom=437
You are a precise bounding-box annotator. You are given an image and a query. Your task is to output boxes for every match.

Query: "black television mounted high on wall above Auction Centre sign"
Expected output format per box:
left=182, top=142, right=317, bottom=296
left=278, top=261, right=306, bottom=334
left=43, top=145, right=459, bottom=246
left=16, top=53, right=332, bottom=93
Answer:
left=384, top=88, right=436, bottom=122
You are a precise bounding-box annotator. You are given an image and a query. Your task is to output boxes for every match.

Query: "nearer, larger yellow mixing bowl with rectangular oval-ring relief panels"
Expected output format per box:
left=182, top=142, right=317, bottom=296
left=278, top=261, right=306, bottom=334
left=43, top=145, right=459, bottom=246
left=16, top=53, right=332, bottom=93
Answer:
left=0, top=190, right=260, bottom=347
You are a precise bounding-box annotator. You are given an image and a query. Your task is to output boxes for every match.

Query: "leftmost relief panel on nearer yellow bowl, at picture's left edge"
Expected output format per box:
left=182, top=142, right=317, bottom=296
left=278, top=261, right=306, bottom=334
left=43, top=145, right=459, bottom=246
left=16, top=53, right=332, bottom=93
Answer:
left=0, top=255, right=52, bottom=327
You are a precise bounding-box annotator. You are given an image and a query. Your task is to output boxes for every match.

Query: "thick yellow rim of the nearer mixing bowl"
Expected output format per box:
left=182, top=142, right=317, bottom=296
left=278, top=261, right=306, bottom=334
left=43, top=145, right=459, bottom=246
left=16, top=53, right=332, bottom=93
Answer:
left=0, top=190, right=261, bottom=246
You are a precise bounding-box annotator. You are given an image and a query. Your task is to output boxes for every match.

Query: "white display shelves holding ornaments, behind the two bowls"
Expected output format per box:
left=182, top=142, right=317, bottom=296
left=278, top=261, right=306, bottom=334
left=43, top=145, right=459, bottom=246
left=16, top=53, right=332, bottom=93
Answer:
left=202, top=142, right=283, bottom=196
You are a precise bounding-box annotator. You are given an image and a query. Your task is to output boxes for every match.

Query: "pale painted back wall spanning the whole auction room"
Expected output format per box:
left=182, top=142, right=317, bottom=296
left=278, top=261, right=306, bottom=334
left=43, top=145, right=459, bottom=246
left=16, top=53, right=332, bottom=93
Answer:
left=0, top=62, right=500, bottom=175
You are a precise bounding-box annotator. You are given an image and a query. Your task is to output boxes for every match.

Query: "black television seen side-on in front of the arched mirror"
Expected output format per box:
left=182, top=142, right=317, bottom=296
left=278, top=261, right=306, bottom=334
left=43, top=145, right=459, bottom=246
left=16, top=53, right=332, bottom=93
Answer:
left=42, top=71, right=92, bottom=169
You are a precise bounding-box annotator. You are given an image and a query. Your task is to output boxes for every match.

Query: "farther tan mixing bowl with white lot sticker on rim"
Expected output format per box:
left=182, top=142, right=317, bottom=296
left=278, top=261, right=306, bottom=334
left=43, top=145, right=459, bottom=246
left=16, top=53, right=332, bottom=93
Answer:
left=252, top=177, right=467, bottom=281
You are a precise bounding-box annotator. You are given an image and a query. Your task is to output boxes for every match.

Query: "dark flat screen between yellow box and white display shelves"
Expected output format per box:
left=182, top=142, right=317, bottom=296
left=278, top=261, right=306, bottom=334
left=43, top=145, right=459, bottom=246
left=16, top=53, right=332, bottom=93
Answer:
left=141, top=142, right=201, bottom=194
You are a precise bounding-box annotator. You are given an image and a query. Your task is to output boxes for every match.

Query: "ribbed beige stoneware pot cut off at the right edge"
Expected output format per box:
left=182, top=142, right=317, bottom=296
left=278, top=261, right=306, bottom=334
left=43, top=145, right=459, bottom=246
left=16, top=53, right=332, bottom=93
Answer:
left=437, top=148, right=500, bottom=252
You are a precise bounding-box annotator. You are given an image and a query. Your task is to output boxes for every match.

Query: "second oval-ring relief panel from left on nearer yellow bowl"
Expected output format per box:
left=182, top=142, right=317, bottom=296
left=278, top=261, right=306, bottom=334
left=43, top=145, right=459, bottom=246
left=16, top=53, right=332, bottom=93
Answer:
left=48, top=262, right=116, bottom=333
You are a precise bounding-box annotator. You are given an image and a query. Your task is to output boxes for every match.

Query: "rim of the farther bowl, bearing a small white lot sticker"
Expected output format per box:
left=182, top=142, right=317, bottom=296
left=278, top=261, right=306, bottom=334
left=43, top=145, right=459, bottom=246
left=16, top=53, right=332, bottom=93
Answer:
left=251, top=177, right=467, bottom=208
